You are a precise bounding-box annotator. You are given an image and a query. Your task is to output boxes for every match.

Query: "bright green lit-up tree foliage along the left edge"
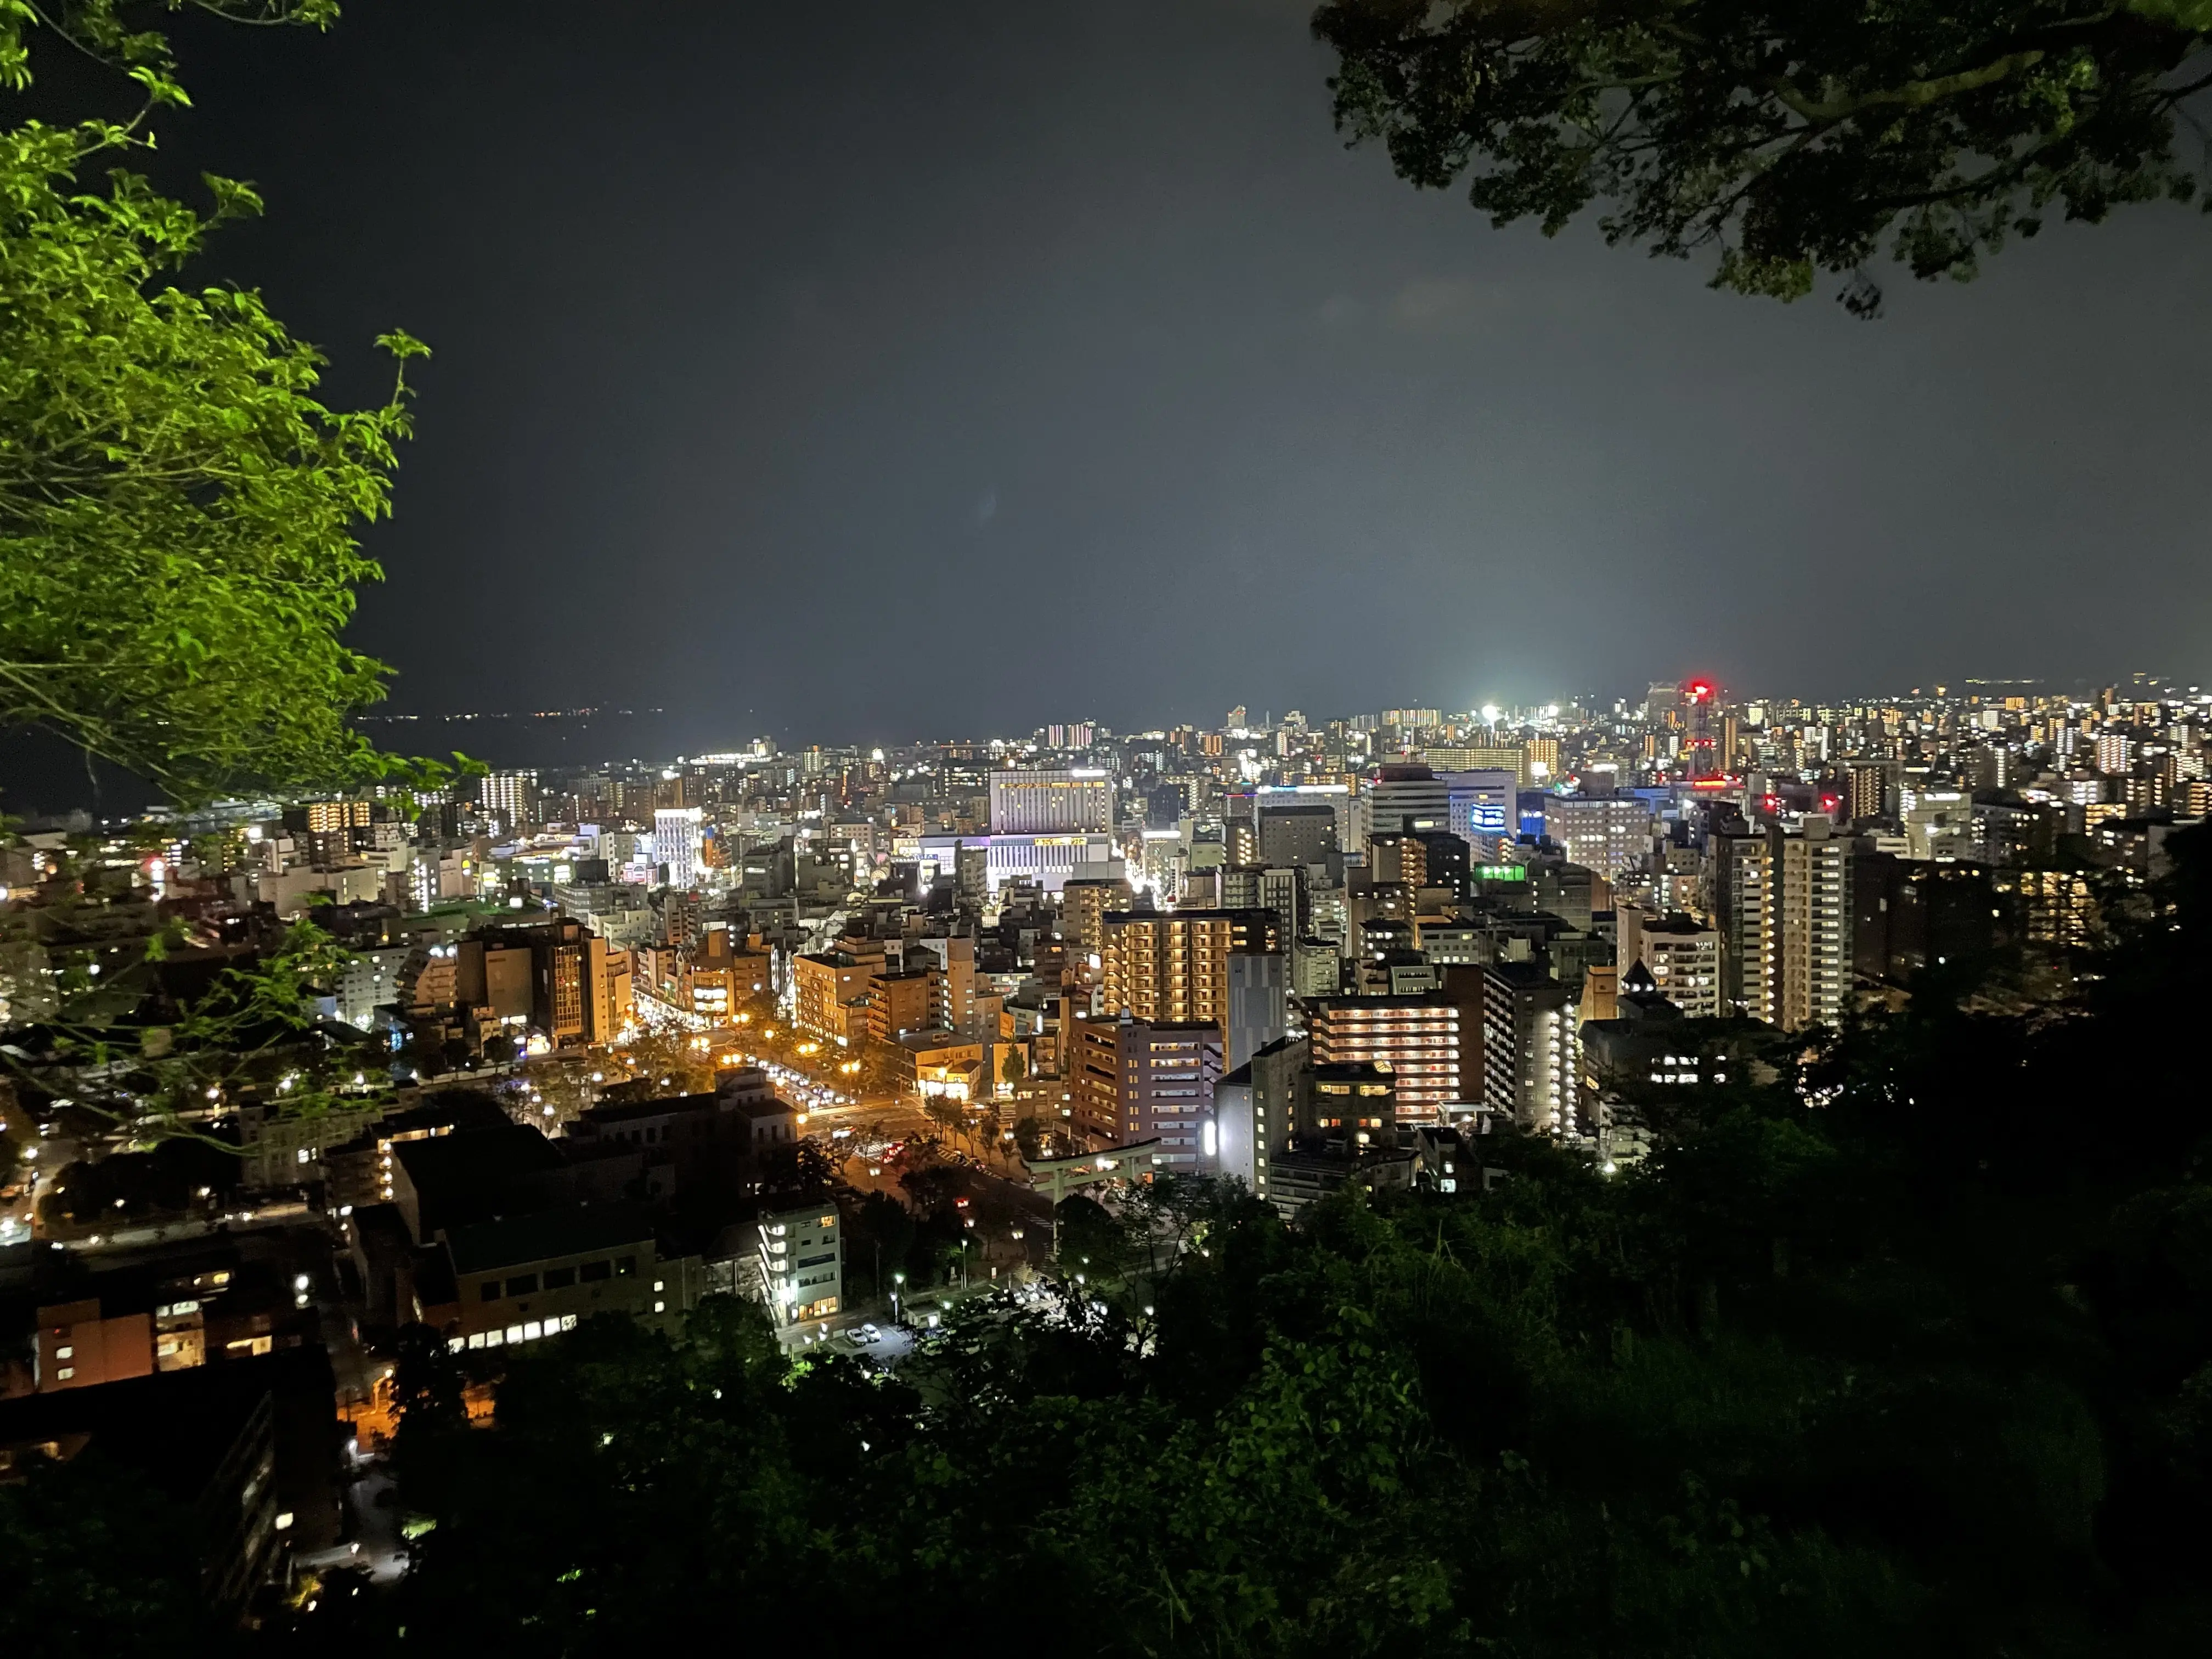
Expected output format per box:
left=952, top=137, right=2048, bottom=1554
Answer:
left=0, top=0, right=449, bottom=803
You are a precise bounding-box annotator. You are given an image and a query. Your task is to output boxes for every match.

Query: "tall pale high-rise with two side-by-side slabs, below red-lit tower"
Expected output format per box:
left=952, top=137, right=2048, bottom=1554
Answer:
left=1707, top=819, right=1852, bottom=1031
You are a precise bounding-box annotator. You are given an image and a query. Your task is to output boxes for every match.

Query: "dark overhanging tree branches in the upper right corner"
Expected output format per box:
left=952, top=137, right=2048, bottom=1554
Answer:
left=1314, top=0, right=2212, bottom=317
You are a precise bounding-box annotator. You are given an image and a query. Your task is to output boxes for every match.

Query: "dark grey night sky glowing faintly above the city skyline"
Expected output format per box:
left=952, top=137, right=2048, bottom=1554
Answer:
left=147, top=0, right=2212, bottom=743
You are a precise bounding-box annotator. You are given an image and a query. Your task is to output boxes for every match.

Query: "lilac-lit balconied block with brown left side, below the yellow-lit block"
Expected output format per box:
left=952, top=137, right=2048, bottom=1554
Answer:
left=1068, top=1013, right=1221, bottom=1172
